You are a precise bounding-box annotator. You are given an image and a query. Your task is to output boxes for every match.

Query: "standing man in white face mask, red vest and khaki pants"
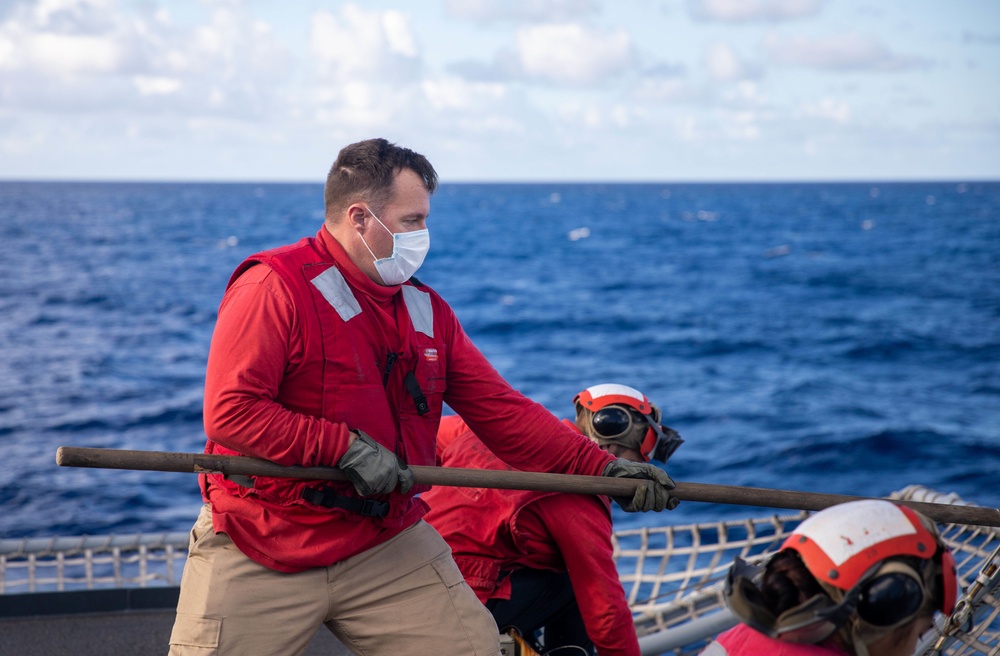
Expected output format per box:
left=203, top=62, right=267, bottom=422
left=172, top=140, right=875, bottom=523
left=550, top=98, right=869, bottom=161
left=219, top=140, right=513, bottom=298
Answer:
left=170, top=139, right=676, bottom=656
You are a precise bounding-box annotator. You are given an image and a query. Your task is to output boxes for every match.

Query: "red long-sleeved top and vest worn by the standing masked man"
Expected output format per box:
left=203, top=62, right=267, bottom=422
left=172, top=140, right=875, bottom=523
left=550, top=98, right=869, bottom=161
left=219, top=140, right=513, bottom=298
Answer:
left=202, top=228, right=611, bottom=572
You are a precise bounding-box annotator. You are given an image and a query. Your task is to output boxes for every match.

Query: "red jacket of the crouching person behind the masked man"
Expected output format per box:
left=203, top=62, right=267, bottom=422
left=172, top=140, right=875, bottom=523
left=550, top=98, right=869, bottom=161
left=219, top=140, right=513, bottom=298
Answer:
left=422, top=417, right=640, bottom=656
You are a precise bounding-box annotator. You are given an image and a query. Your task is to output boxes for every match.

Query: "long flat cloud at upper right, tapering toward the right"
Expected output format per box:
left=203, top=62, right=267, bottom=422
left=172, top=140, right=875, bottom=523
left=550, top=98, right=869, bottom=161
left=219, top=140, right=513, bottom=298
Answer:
left=764, top=33, right=927, bottom=71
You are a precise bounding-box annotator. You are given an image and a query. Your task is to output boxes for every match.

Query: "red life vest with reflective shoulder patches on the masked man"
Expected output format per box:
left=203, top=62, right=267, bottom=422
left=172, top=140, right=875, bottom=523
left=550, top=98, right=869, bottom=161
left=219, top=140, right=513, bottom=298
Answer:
left=203, top=229, right=450, bottom=569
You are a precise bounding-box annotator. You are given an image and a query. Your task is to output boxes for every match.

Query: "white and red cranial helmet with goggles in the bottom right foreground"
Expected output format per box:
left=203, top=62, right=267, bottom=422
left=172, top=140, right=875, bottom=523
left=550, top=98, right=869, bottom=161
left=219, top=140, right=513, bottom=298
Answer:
left=725, top=499, right=958, bottom=648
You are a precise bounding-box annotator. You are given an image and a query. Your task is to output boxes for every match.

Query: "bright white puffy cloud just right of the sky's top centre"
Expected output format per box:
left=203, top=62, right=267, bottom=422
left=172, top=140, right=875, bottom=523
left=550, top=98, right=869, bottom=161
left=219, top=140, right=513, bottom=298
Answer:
left=517, top=24, right=633, bottom=85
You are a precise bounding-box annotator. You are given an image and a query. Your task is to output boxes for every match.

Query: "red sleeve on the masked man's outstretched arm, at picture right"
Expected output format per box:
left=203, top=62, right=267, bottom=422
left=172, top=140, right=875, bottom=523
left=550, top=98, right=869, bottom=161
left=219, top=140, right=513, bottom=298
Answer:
left=434, top=294, right=615, bottom=476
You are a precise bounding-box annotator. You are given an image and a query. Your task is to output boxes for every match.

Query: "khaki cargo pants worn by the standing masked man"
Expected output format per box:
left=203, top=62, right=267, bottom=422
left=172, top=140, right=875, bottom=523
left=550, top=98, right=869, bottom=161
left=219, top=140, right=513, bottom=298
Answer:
left=170, top=505, right=508, bottom=656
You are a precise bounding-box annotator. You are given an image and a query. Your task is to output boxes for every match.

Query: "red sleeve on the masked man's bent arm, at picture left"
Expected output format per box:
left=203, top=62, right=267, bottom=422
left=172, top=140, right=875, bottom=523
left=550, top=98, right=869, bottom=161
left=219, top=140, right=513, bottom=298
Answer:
left=204, top=264, right=349, bottom=467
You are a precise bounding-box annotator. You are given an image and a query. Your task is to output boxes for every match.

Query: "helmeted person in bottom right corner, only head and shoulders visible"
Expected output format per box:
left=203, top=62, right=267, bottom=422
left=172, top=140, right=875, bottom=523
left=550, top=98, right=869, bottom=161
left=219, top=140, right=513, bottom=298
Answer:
left=702, top=499, right=958, bottom=656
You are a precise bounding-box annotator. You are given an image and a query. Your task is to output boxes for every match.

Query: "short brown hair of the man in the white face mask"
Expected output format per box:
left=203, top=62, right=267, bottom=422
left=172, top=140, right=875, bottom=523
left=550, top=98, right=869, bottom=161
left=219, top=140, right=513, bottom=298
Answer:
left=323, top=139, right=437, bottom=221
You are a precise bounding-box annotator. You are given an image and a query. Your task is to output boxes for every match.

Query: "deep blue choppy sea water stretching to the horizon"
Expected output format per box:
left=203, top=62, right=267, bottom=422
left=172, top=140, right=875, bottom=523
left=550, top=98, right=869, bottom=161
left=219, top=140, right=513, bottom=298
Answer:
left=0, top=182, right=1000, bottom=538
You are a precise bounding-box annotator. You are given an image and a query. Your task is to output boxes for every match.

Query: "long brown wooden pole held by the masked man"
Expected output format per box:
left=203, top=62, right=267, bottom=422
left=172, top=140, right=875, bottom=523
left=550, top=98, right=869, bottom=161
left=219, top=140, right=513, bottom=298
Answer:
left=56, top=446, right=1000, bottom=527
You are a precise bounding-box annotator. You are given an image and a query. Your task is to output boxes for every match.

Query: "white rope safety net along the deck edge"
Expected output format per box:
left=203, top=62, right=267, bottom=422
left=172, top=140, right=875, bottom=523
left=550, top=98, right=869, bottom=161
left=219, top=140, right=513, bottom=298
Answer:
left=0, top=486, right=1000, bottom=656
